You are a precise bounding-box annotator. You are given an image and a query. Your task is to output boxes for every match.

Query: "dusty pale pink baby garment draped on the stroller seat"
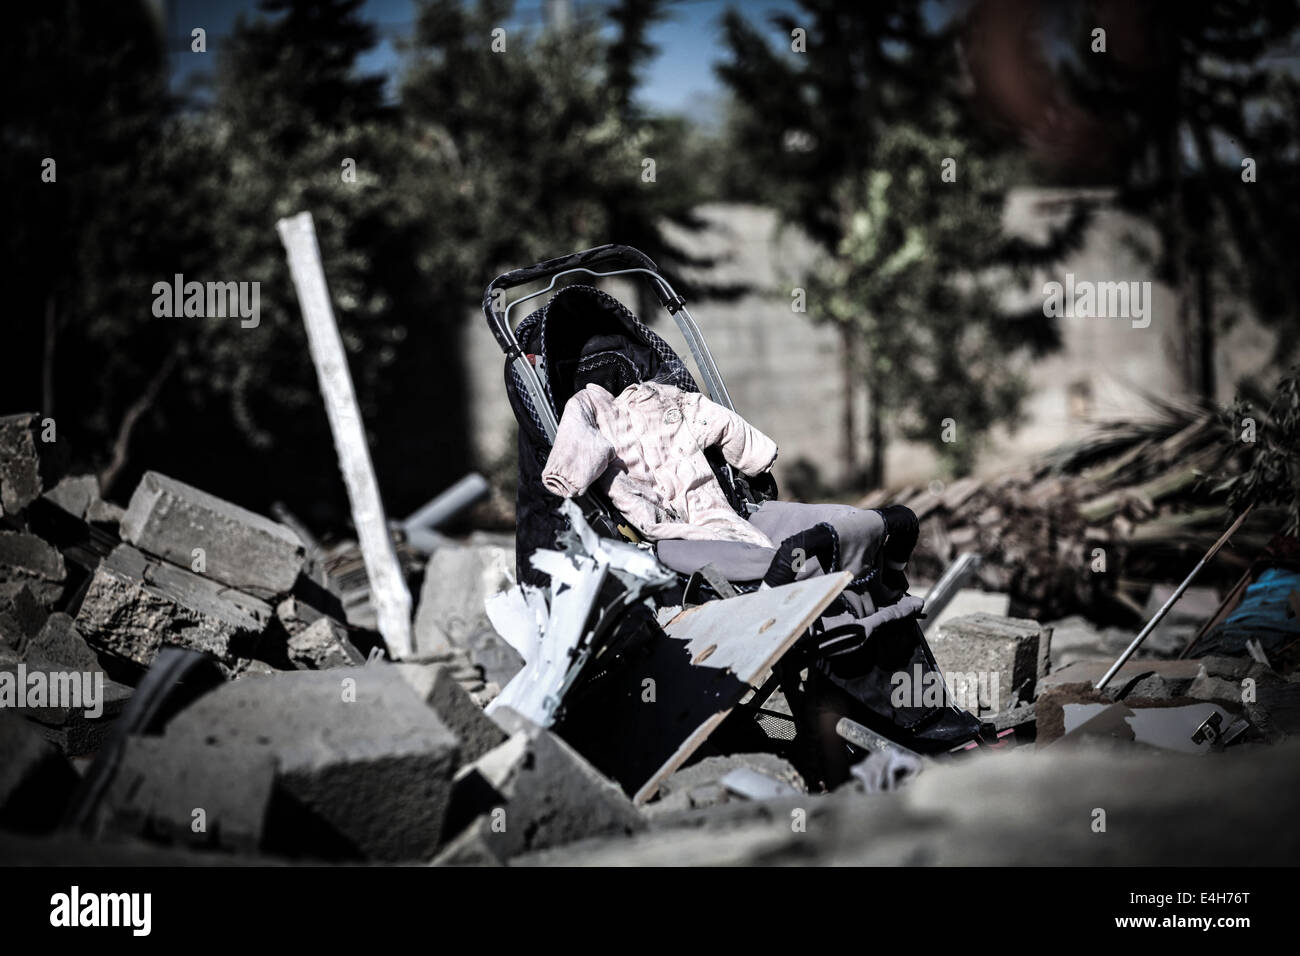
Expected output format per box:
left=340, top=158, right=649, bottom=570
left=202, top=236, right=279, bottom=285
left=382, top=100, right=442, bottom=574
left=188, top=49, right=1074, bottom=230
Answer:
left=542, top=382, right=776, bottom=548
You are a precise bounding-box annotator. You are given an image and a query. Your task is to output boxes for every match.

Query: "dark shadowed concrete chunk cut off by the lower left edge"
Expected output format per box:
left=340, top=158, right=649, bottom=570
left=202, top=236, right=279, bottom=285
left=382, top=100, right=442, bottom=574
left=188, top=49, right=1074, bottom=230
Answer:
left=0, top=713, right=78, bottom=831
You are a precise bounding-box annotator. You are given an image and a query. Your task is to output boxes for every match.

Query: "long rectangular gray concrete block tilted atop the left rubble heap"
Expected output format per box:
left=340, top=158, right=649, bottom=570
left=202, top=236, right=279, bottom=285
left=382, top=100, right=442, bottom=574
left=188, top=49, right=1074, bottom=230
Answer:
left=121, top=471, right=307, bottom=597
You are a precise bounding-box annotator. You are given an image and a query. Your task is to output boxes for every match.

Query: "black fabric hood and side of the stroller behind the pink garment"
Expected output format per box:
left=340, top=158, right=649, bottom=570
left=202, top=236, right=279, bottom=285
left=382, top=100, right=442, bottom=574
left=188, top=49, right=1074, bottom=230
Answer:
left=506, top=285, right=745, bottom=587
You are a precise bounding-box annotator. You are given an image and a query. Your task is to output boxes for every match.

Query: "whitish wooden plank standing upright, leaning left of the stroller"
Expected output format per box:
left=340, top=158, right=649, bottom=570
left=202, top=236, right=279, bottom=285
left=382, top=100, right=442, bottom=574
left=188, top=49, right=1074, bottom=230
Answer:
left=276, top=212, right=415, bottom=658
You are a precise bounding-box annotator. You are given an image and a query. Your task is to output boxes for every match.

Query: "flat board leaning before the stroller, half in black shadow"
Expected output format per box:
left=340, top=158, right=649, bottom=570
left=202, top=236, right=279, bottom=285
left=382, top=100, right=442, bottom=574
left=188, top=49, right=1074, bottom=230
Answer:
left=556, top=572, right=852, bottom=804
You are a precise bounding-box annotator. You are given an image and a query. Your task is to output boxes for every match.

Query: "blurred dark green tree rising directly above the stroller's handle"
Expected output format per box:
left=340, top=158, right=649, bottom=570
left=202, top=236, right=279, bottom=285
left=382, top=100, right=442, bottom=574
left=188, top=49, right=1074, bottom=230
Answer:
left=402, top=0, right=728, bottom=312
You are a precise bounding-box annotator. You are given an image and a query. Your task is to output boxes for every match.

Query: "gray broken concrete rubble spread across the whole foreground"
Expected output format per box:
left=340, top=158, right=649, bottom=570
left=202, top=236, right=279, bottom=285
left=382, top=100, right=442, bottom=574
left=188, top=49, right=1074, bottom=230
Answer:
left=0, top=403, right=1300, bottom=865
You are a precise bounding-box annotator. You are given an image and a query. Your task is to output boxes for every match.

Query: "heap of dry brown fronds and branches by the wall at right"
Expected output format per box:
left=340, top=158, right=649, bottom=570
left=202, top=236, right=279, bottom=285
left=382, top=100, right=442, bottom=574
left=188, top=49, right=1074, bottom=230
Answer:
left=878, top=403, right=1282, bottom=623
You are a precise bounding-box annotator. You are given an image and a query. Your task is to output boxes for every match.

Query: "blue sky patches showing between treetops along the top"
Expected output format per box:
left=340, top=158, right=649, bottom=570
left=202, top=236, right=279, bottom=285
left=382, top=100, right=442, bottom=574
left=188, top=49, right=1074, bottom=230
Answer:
left=163, top=0, right=794, bottom=112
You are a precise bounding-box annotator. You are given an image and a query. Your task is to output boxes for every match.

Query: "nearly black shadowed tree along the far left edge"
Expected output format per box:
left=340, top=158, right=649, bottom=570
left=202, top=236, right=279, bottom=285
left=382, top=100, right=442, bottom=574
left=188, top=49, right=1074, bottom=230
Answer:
left=0, top=0, right=205, bottom=494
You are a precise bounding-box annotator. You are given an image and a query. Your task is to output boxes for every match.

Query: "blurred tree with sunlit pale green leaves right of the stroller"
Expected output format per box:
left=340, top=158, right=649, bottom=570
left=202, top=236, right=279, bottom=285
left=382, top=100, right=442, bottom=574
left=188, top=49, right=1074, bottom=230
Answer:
left=719, top=0, right=1088, bottom=486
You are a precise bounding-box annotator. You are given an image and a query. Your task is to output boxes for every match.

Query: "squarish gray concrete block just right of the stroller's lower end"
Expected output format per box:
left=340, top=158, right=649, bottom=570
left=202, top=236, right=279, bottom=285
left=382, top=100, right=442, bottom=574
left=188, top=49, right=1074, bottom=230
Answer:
left=930, top=614, right=1052, bottom=715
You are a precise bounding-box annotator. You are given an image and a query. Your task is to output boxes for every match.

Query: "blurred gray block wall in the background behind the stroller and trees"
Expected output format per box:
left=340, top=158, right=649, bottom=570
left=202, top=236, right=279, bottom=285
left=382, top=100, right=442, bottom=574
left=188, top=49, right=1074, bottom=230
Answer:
left=467, top=195, right=1271, bottom=494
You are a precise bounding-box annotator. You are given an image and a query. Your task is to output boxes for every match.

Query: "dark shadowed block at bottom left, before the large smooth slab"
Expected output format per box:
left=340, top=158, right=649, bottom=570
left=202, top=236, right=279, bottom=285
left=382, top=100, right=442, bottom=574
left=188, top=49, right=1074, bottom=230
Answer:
left=100, top=736, right=276, bottom=855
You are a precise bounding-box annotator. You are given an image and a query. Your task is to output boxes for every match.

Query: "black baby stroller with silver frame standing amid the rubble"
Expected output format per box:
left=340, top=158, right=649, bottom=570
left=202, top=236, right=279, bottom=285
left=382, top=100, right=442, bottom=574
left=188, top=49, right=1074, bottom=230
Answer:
left=484, top=245, right=980, bottom=786
